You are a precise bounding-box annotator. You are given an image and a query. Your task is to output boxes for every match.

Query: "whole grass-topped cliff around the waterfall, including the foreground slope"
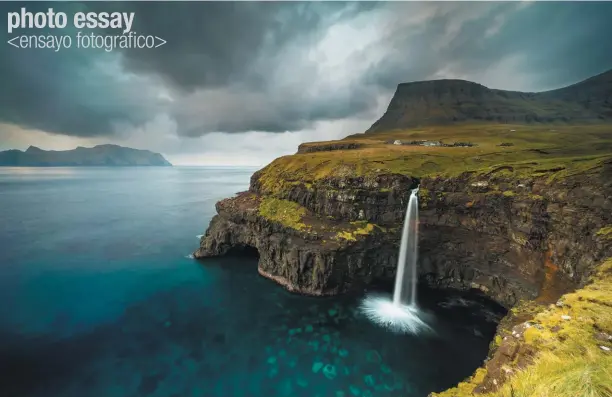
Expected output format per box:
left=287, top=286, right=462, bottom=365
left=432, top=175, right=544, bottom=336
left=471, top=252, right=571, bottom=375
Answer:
left=194, top=70, right=612, bottom=397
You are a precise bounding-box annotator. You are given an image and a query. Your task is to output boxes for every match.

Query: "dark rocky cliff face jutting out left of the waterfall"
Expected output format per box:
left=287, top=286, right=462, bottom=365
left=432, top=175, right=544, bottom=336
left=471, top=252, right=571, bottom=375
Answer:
left=194, top=192, right=396, bottom=295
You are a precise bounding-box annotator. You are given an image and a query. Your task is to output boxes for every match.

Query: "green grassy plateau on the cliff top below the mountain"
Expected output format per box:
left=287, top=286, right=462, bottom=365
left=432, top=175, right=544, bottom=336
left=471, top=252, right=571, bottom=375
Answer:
left=260, top=124, right=612, bottom=187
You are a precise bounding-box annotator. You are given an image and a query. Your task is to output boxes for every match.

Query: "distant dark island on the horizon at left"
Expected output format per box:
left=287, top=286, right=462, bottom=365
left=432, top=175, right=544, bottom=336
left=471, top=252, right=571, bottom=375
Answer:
left=0, top=145, right=172, bottom=167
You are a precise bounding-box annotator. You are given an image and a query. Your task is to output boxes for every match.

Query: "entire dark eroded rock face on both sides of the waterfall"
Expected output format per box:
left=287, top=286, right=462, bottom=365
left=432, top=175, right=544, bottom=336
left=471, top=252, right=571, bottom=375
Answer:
left=195, top=159, right=612, bottom=306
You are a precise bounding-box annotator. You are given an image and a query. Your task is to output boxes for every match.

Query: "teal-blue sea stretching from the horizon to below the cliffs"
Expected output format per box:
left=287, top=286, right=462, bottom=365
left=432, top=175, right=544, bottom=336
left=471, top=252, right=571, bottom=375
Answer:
left=0, top=167, right=499, bottom=397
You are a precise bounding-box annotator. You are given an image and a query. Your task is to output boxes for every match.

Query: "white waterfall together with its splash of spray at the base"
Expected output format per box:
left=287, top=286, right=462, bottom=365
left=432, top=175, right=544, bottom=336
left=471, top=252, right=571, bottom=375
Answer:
left=361, top=187, right=431, bottom=334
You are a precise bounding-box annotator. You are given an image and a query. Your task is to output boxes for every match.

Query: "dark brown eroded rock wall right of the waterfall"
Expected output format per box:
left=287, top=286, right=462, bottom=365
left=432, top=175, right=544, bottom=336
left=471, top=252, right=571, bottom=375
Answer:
left=420, top=169, right=612, bottom=305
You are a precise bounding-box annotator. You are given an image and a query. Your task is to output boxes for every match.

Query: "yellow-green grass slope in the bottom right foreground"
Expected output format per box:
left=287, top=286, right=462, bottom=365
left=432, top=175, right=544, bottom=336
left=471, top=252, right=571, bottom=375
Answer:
left=435, top=258, right=612, bottom=397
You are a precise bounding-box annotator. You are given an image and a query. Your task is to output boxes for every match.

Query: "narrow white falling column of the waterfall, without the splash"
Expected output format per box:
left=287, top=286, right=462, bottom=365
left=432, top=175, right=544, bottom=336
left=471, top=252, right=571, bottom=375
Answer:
left=393, top=187, right=419, bottom=306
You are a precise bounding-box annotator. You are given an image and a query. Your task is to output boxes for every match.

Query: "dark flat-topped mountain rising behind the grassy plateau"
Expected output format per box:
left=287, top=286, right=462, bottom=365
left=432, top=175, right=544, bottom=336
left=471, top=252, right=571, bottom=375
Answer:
left=366, top=70, right=612, bottom=133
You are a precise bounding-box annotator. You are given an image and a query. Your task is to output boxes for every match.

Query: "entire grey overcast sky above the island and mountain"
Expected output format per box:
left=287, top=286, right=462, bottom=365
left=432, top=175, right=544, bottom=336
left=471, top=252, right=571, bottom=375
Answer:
left=0, top=2, right=612, bottom=165
